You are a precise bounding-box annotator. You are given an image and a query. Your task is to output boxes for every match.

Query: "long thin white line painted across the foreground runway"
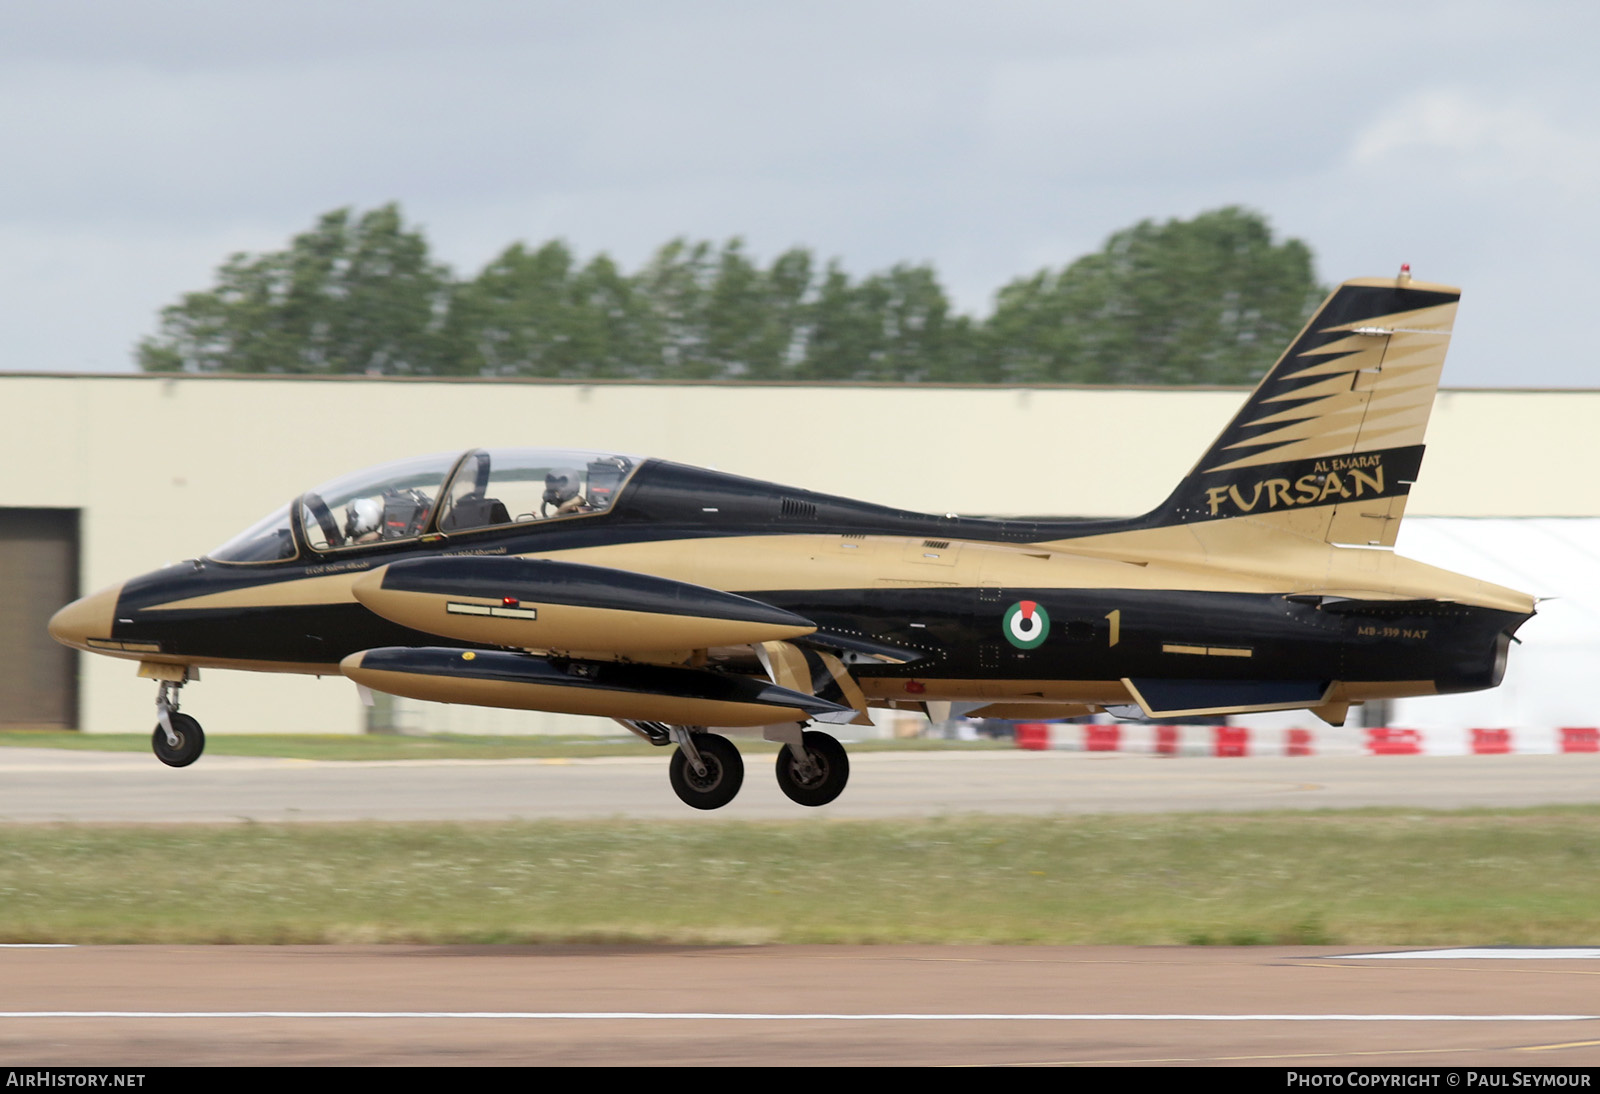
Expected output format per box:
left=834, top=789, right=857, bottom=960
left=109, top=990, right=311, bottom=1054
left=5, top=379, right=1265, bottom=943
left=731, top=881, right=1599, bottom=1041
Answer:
left=0, top=1011, right=1600, bottom=1022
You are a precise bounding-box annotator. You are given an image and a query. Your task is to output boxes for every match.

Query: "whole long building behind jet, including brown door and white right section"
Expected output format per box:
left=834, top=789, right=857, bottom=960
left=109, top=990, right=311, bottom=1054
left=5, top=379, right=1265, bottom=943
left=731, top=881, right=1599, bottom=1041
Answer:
left=0, top=373, right=1600, bottom=733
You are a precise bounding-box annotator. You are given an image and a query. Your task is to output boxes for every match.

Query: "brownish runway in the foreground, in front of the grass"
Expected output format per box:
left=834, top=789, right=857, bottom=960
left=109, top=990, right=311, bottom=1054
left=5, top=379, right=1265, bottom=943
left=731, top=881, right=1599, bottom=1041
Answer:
left=0, top=947, right=1600, bottom=1070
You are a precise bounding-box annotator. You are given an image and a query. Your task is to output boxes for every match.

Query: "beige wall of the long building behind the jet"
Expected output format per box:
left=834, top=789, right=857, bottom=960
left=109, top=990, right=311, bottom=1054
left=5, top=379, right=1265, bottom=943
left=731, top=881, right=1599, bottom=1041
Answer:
left=0, top=374, right=1600, bottom=733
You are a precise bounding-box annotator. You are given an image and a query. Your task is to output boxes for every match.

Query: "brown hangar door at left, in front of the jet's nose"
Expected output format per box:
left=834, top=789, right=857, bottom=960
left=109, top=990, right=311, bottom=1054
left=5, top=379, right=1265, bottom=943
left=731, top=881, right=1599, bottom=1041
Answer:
left=0, top=509, right=78, bottom=729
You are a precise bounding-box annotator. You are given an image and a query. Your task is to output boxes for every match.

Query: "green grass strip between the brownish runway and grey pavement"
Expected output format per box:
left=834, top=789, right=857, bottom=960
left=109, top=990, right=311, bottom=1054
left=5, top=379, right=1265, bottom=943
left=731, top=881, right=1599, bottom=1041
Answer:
left=0, top=806, right=1600, bottom=947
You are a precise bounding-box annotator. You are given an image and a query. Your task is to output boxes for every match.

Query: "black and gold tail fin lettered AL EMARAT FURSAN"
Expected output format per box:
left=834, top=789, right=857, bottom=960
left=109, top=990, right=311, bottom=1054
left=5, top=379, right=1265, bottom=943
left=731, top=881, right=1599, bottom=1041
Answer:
left=1144, top=274, right=1461, bottom=547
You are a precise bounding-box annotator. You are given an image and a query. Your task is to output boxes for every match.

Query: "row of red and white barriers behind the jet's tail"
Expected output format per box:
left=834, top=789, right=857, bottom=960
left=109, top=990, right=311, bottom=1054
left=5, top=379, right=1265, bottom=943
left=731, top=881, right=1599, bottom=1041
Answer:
left=1016, top=721, right=1600, bottom=757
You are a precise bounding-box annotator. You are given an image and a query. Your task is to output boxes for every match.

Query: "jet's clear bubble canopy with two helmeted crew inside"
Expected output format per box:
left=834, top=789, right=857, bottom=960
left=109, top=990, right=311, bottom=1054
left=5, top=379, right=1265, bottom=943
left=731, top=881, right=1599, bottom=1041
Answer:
left=206, top=448, right=640, bottom=563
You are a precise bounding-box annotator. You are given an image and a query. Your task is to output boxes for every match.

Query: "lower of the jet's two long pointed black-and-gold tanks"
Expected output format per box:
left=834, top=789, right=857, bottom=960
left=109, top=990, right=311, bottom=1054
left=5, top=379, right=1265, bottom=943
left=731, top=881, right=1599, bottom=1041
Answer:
left=341, top=646, right=854, bottom=726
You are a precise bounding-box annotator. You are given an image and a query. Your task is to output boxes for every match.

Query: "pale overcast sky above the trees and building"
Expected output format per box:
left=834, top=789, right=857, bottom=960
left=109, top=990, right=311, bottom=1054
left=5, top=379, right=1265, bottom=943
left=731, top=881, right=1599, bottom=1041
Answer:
left=0, top=0, right=1600, bottom=387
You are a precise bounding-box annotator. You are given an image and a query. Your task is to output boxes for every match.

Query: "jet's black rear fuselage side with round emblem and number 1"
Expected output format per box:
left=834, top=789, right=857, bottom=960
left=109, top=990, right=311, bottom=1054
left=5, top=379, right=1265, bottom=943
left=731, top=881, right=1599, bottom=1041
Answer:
left=787, top=589, right=1525, bottom=707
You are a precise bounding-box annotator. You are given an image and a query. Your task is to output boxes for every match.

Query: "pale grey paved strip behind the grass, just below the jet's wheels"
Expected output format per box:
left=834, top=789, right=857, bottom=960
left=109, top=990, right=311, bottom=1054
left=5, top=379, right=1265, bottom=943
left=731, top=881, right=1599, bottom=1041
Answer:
left=0, top=749, right=1600, bottom=824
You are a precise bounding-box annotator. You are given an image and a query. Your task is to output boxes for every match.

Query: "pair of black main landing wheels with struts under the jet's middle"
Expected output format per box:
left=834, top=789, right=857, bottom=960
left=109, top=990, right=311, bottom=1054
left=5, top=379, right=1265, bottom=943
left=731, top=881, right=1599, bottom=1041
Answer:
left=619, top=718, right=850, bottom=809
